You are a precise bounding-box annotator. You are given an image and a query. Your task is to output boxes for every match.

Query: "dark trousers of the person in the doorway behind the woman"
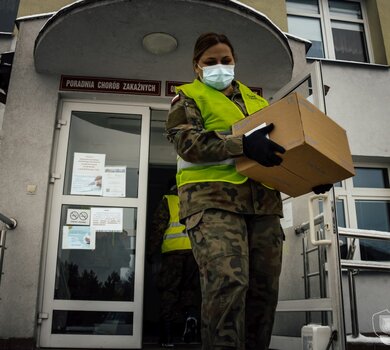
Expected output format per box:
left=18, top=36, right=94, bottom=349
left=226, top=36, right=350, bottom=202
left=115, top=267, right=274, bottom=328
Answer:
left=157, top=250, right=200, bottom=322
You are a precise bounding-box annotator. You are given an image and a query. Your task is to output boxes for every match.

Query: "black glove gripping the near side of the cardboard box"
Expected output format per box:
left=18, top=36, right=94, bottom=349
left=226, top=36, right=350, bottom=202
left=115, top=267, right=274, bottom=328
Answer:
left=242, top=123, right=286, bottom=167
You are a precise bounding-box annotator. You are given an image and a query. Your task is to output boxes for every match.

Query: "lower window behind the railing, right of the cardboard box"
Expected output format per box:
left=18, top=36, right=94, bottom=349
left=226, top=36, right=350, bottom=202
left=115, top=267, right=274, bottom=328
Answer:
left=335, top=165, right=390, bottom=261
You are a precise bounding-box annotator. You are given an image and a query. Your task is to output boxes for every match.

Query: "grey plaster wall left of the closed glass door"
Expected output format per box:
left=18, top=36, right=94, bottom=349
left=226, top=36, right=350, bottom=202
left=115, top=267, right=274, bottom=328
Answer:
left=0, top=20, right=58, bottom=338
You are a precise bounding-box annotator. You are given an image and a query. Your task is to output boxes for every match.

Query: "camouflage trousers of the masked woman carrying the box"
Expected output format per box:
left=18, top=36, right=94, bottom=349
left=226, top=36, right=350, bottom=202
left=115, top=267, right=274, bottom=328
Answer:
left=186, top=209, right=283, bottom=350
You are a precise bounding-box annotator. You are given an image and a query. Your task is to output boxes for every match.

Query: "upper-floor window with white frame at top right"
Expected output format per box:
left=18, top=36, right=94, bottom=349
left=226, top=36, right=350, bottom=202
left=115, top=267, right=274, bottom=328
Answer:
left=286, top=0, right=369, bottom=62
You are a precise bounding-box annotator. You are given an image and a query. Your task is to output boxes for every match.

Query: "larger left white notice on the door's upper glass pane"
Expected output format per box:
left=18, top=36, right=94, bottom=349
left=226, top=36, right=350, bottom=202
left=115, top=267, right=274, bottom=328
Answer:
left=70, top=152, right=106, bottom=196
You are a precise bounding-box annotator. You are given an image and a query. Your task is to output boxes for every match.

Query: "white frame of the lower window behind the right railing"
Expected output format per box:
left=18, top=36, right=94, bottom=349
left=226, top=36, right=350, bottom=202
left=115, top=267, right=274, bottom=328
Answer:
left=334, top=163, right=390, bottom=260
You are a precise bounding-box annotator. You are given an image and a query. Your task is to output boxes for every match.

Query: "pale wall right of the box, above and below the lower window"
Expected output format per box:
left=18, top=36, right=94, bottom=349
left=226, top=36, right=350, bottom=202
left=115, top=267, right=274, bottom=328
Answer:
left=323, top=61, right=390, bottom=333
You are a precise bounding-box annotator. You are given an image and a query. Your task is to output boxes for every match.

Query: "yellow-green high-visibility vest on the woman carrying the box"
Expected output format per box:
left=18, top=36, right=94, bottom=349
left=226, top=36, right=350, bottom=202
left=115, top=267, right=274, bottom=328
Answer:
left=176, top=79, right=268, bottom=187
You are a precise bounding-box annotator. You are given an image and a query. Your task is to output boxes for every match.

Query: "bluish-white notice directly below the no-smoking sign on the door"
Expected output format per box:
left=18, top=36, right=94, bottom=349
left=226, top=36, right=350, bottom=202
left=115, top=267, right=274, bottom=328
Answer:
left=62, top=226, right=96, bottom=250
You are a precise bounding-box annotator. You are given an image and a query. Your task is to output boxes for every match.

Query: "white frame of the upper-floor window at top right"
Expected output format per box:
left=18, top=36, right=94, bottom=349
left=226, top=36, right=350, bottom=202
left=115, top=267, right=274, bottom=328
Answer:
left=286, top=0, right=374, bottom=63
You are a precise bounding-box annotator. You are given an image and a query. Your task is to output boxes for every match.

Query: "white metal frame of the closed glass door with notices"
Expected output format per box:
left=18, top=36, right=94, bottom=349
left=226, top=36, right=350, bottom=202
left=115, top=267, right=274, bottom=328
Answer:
left=37, top=100, right=150, bottom=349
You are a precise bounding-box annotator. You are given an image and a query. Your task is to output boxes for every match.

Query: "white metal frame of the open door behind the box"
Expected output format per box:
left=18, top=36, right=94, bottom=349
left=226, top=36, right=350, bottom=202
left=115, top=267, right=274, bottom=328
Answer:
left=269, top=61, right=346, bottom=350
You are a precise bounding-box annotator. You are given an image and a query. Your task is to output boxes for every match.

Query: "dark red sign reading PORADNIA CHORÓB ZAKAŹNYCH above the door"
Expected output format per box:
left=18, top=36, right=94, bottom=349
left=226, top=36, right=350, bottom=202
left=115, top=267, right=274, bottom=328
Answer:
left=60, top=75, right=161, bottom=96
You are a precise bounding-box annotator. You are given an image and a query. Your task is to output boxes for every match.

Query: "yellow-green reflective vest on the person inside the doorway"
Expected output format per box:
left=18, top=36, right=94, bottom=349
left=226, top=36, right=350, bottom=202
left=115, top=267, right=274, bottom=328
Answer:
left=161, top=195, right=191, bottom=253
